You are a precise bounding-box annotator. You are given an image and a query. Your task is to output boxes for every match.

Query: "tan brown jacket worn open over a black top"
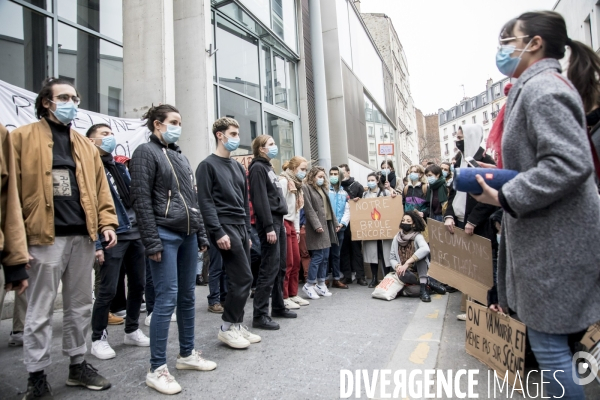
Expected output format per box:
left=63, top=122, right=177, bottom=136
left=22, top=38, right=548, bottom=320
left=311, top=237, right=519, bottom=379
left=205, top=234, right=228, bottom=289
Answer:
left=11, top=119, right=119, bottom=246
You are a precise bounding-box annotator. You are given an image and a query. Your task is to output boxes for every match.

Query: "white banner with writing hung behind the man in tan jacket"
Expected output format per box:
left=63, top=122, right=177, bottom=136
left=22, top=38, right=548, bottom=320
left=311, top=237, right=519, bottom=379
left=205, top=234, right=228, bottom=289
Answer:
left=0, top=80, right=150, bottom=158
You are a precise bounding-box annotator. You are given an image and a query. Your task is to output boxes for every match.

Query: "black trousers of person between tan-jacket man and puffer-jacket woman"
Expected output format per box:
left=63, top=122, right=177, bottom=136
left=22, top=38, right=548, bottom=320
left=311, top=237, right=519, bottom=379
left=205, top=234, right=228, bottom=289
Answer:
left=92, top=239, right=146, bottom=341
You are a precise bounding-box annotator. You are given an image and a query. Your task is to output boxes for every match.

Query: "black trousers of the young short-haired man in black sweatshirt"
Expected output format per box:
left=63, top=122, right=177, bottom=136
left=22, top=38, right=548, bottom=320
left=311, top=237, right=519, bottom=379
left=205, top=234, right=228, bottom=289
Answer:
left=217, top=225, right=252, bottom=324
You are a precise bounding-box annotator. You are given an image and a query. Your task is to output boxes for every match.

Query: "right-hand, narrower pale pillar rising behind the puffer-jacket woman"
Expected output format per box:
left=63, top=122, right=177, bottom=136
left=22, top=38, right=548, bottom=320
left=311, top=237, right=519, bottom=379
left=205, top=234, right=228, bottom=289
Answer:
left=173, top=0, right=215, bottom=170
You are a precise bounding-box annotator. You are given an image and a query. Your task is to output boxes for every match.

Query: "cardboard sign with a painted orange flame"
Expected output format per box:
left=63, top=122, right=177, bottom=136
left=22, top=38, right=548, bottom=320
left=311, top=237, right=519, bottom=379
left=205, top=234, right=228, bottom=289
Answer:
left=349, top=196, right=404, bottom=240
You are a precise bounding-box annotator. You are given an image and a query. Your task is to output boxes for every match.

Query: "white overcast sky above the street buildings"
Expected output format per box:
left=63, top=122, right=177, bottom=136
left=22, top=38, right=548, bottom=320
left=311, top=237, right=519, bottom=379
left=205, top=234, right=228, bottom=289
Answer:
left=360, top=0, right=556, bottom=114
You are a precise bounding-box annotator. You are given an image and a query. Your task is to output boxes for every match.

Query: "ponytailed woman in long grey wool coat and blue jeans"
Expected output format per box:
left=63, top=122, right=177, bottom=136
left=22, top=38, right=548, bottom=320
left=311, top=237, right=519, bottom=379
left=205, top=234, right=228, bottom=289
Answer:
left=476, top=11, right=600, bottom=399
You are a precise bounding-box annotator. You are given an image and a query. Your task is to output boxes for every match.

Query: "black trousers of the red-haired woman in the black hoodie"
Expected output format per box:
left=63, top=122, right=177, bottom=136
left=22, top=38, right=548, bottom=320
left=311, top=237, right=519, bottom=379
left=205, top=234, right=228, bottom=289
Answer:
left=254, top=217, right=287, bottom=318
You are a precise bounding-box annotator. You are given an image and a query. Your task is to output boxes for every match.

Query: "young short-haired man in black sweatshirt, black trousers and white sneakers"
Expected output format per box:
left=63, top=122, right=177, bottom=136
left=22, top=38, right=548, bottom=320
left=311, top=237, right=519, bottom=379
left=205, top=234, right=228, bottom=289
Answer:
left=196, top=118, right=261, bottom=349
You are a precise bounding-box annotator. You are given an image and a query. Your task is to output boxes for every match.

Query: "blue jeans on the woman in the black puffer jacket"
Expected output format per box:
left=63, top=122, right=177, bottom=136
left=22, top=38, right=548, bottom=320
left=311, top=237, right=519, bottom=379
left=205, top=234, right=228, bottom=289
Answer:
left=150, top=226, right=198, bottom=371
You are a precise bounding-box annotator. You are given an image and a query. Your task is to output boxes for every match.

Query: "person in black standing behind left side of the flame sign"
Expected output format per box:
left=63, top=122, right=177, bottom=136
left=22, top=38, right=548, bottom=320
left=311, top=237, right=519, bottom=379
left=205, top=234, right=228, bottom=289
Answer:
left=339, top=164, right=367, bottom=286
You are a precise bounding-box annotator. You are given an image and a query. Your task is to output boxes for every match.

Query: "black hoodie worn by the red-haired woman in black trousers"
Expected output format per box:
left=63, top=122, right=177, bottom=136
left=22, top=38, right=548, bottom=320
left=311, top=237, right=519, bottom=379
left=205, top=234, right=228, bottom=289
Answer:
left=248, top=157, right=287, bottom=232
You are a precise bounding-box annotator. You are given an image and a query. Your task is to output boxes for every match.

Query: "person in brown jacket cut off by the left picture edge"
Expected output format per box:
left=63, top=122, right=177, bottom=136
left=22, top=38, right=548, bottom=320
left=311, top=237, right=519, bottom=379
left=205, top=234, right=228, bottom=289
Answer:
left=0, top=124, right=28, bottom=345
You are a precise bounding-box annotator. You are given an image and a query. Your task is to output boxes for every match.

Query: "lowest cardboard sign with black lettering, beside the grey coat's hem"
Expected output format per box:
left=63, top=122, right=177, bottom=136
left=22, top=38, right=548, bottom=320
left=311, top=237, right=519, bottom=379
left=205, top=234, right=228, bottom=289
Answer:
left=465, top=301, right=527, bottom=389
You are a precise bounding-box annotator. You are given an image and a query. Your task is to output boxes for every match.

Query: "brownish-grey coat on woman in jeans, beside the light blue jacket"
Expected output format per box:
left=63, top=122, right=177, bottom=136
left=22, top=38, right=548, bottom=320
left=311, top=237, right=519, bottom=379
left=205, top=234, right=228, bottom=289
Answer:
left=302, top=184, right=338, bottom=250
